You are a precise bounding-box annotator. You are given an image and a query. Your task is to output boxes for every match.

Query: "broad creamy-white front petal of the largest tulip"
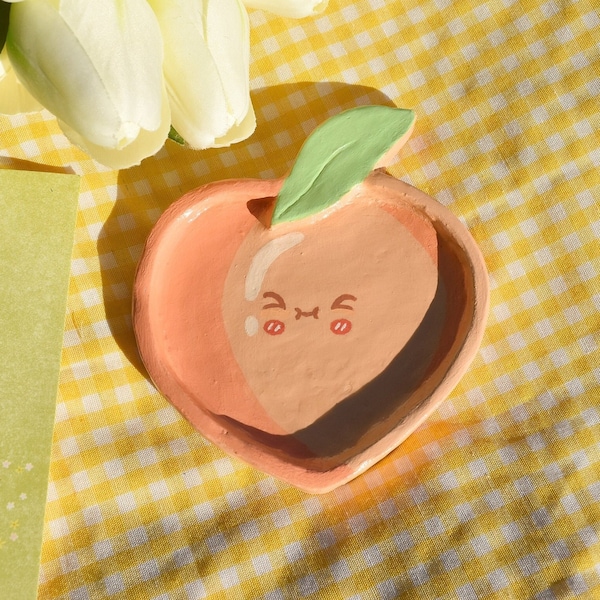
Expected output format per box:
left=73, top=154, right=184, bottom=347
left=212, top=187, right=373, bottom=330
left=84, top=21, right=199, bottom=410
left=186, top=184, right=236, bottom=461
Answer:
left=7, top=0, right=162, bottom=148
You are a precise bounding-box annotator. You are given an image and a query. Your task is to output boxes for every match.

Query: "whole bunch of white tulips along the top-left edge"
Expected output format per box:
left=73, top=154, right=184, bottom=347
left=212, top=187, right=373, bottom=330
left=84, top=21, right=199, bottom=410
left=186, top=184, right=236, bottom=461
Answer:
left=0, top=0, right=328, bottom=169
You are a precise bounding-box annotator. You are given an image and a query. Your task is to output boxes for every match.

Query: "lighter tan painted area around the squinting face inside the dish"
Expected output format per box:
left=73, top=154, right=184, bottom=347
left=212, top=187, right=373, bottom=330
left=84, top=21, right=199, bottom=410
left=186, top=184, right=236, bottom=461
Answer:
left=222, top=206, right=437, bottom=433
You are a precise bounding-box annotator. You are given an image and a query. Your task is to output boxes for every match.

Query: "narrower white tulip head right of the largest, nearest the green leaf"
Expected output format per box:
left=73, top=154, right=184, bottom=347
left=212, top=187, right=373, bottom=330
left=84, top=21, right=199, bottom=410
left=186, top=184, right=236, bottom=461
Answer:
left=149, top=0, right=254, bottom=149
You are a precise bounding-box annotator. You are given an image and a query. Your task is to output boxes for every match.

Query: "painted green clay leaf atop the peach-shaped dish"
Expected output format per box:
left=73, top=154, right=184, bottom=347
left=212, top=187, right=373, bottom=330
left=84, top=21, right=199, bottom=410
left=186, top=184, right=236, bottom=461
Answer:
left=271, top=106, right=415, bottom=225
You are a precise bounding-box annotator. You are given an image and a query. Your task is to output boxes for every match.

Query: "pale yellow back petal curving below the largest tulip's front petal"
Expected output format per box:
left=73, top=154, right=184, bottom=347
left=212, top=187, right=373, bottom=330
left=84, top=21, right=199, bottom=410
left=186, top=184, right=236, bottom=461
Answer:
left=58, top=84, right=171, bottom=169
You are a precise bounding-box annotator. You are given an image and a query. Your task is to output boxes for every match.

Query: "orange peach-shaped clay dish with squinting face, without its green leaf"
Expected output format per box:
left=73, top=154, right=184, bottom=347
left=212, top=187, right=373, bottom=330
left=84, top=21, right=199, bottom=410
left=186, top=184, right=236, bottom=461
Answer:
left=133, top=109, right=488, bottom=493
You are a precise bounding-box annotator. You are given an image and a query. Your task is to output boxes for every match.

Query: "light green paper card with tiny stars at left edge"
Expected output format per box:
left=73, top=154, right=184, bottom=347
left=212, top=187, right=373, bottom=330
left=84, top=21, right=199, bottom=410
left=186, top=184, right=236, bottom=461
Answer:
left=0, top=169, right=79, bottom=600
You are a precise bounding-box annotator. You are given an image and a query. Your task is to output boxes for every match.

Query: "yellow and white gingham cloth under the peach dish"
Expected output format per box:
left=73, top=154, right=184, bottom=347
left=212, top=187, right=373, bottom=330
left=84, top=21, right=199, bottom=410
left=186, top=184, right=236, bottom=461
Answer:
left=0, top=0, right=600, bottom=600
